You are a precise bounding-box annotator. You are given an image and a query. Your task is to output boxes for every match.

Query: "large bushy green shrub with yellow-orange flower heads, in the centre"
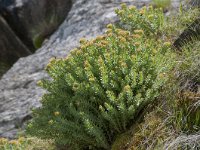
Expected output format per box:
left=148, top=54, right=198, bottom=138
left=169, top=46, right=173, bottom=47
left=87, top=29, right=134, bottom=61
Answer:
left=27, top=6, right=171, bottom=150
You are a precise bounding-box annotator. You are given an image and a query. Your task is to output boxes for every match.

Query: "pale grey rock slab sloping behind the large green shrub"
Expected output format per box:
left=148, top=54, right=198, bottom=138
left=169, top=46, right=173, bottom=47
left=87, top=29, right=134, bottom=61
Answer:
left=0, top=0, right=181, bottom=138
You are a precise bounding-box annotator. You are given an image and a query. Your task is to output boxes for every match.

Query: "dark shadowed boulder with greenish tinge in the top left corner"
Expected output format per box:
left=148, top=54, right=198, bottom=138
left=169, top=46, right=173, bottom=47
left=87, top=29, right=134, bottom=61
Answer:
left=0, top=0, right=72, bottom=51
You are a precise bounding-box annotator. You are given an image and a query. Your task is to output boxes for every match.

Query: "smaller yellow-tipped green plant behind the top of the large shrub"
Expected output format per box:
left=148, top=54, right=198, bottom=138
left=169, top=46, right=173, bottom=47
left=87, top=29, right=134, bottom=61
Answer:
left=115, top=4, right=164, bottom=36
